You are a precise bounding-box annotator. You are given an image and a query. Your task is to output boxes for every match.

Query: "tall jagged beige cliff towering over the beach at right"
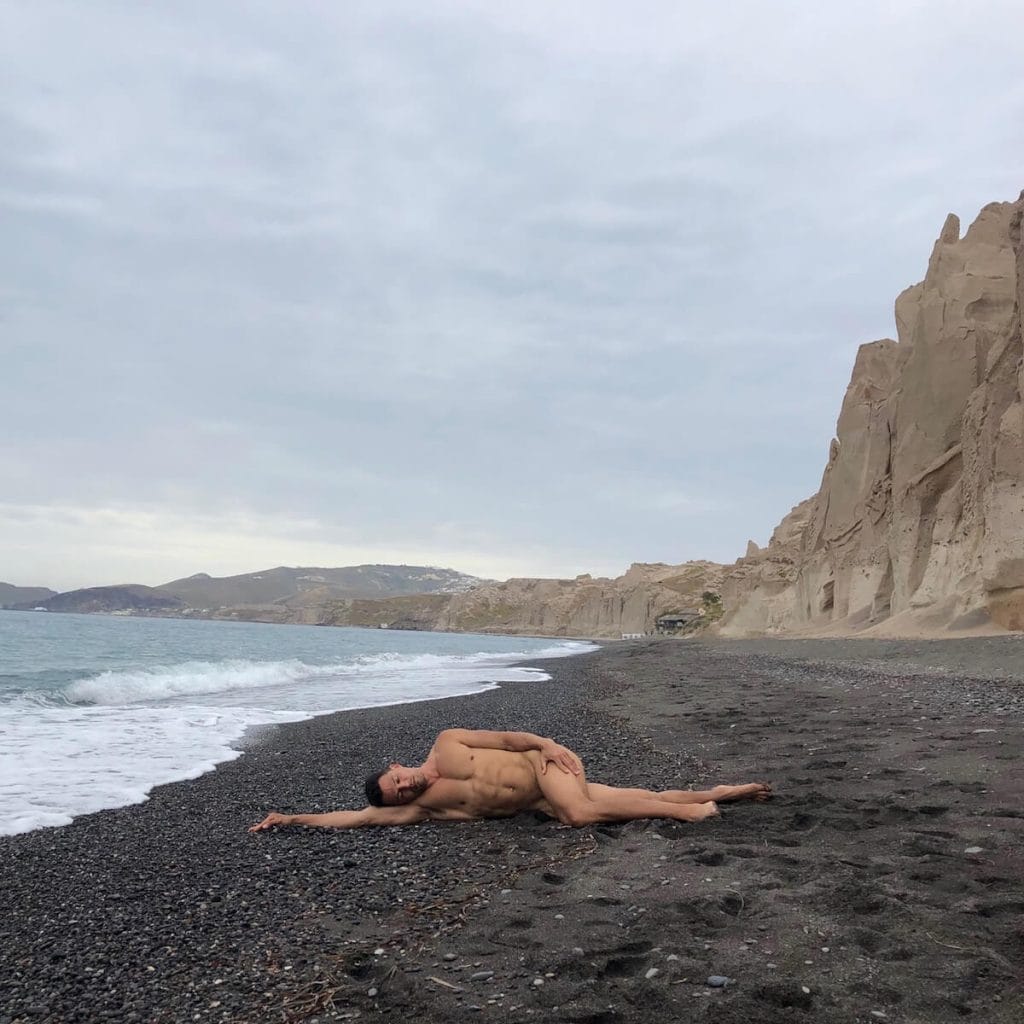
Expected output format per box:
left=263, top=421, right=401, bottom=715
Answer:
left=721, top=194, right=1024, bottom=636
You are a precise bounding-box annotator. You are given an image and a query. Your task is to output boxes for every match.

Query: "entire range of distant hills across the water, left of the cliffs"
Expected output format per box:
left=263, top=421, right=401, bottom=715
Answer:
left=0, top=565, right=492, bottom=615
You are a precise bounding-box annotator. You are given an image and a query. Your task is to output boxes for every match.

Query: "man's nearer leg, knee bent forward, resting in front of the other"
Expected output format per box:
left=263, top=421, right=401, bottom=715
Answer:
left=537, top=769, right=718, bottom=825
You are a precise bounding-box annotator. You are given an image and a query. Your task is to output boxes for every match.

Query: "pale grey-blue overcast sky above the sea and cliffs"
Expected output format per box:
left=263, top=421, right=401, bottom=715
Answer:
left=0, top=0, right=1024, bottom=589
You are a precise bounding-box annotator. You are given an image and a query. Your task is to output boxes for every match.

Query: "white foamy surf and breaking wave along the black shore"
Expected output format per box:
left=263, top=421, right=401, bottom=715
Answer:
left=0, top=643, right=591, bottom=835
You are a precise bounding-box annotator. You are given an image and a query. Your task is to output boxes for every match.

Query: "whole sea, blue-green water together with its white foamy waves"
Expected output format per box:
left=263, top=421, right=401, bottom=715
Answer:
left=0, top=611, right=594, bottom=835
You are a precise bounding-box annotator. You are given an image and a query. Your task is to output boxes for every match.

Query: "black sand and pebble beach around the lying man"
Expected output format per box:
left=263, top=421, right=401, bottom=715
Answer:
left=0, top=637, right=1024, bottom=1024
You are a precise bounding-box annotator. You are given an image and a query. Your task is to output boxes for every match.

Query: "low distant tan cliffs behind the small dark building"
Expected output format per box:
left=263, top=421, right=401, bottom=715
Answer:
left=434, top=562, right=723, bottom=638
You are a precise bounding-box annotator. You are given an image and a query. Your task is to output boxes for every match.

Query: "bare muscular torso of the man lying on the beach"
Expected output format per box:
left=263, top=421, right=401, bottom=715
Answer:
left=416, top=741, right=544, bottom=819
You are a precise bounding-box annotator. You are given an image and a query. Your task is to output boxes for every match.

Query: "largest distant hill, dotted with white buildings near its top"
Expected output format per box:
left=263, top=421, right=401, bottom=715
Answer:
left=155, top=565, right=489, bottom=609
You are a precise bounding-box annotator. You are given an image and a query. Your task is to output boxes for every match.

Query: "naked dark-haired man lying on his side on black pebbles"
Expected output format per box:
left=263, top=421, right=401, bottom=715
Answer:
left=249, top=729, right=771, bottom=831
